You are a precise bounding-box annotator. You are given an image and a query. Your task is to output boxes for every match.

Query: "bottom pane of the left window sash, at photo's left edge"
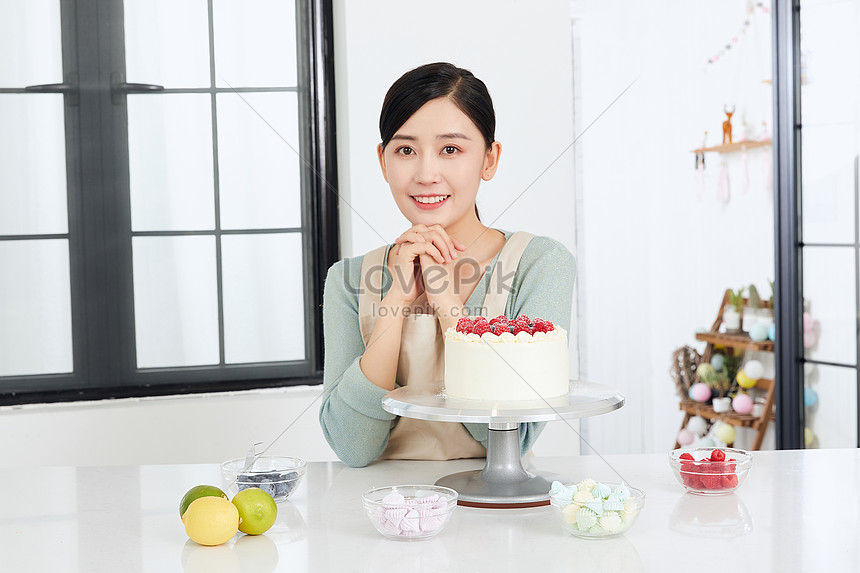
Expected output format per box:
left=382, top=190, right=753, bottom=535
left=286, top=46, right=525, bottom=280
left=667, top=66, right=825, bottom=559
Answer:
left=0, top=239, right=73, bottom=376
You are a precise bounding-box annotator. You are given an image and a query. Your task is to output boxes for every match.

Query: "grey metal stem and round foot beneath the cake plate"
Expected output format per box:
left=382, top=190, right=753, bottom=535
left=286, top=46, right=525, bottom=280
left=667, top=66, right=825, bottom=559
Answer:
left=436, top=423, right=568, bottom=509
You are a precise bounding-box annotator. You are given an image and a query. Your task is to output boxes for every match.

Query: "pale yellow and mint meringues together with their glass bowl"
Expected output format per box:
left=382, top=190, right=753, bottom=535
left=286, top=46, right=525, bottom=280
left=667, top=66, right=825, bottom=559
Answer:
left=549, top=479, right=645, bottom=539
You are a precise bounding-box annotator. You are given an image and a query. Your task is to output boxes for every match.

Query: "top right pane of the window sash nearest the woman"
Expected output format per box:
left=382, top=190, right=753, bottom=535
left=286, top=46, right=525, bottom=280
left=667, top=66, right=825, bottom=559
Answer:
left=212, top=0, right=296, bottom=88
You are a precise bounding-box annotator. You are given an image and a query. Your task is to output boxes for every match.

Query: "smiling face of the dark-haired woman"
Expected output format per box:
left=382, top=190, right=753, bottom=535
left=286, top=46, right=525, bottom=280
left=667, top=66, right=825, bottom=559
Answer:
left=377, top=98, right=501, bottom=229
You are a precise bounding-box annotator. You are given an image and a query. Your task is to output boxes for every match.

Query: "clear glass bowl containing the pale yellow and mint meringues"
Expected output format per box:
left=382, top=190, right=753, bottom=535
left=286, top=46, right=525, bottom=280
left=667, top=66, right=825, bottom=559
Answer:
left=549, top=483, right=645, bottom=539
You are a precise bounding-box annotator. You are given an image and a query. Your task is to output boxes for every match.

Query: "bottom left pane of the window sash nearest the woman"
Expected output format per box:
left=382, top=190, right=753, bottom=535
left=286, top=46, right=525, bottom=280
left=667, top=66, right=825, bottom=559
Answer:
left=132, top=236, right=219, bottom=368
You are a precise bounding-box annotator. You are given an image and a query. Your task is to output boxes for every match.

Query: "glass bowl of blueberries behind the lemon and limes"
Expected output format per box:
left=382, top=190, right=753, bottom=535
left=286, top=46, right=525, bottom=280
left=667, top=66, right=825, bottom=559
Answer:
left=221, top=456, right=307, bottom=502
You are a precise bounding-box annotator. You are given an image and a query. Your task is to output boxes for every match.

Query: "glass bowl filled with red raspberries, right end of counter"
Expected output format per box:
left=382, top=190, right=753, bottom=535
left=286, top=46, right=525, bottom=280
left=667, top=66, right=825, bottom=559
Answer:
left=669, top=448, right=752, bottom=495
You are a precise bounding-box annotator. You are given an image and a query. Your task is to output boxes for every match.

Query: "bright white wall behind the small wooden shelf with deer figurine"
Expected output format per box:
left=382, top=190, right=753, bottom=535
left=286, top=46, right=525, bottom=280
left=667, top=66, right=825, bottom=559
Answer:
left=572, top=0, right=774, bottom=453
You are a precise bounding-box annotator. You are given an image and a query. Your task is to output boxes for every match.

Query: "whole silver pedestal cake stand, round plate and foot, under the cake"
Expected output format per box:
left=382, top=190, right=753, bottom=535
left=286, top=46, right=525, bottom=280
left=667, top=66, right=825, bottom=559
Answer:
left=382, top=380, right=624, bottom=509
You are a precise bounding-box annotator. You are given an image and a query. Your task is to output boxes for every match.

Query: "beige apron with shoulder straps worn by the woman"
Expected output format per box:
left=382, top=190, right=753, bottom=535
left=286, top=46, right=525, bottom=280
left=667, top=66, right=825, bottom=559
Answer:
left=358, top=231, right=533, bottom=460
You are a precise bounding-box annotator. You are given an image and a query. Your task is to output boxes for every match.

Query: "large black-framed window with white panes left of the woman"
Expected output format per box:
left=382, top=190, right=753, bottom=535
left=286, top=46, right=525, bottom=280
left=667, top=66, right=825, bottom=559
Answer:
left=0, top=0, right=337, bottom=403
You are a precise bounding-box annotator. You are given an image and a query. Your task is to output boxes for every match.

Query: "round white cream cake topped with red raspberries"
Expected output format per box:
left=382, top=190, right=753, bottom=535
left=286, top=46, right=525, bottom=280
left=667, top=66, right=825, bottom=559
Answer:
left=445, top=315, right=570, bottom=401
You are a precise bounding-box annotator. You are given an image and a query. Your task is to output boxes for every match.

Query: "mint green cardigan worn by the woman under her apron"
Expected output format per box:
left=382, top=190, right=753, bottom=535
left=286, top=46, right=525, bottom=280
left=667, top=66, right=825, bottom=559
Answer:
left=319, top=231, right=576, bottom=467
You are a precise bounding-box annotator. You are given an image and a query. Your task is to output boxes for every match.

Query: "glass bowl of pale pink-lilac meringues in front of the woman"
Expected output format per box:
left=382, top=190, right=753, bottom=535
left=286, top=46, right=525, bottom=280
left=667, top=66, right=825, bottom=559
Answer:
left=361, top=485, right=457, bottom=540
